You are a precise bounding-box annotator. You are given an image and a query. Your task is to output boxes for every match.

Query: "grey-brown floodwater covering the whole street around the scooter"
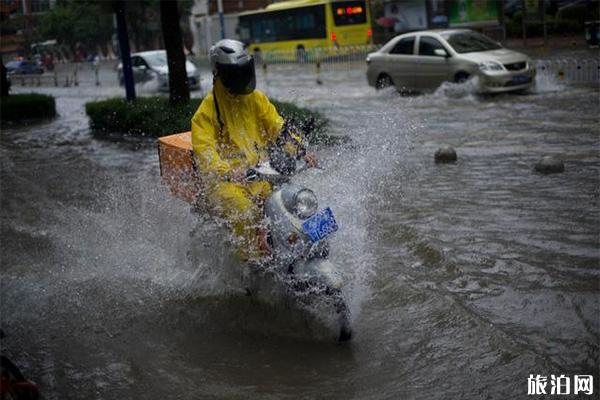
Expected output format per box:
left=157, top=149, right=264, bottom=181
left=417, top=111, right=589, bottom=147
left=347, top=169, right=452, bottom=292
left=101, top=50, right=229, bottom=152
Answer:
left=0, top=66, right=600, bottom=399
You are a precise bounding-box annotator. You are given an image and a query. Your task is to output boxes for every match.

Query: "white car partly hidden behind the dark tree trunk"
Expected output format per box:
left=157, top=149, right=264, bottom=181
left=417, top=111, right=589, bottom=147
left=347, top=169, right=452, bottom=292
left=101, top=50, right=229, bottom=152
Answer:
left=117, top=50, right=200, bottom=90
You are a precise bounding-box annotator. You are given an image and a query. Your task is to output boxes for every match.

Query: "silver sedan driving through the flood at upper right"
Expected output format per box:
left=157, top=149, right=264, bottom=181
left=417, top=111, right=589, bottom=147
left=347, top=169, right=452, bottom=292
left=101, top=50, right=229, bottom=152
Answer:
left=366, top=29, right=535, bottom=93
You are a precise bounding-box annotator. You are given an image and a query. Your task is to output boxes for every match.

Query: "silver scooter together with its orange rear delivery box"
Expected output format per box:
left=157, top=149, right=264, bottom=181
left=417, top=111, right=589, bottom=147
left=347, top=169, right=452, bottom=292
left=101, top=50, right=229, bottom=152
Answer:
left=159, top=127, right=352, bottom=341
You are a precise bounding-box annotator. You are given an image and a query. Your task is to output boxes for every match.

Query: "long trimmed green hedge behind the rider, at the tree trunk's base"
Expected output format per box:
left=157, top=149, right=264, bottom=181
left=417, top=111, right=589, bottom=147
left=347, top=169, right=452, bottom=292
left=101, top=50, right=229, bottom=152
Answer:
left=85, top=96, right=333, bottom=143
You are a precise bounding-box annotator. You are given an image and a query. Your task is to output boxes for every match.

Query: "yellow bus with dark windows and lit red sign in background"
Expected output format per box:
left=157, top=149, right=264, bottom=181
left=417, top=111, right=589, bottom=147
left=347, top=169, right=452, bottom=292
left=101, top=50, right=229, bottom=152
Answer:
left=238, top=0, right=373, bottom=59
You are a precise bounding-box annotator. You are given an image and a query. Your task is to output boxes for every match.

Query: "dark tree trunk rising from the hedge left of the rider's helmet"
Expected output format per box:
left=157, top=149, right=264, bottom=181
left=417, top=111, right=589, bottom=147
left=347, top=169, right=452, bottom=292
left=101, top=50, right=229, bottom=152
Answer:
left=160, top=0, right=190, bottom=104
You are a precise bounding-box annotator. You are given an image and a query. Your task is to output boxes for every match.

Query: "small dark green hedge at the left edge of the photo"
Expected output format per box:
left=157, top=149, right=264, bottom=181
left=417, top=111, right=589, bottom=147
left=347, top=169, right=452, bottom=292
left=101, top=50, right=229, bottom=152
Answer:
left=0, top=93, right=56, bottom=121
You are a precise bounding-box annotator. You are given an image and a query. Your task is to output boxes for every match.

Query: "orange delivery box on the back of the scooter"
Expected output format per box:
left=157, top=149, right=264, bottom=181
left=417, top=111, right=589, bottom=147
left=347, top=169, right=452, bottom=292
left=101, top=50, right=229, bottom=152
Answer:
left=158, top=132, right=202, bottom=204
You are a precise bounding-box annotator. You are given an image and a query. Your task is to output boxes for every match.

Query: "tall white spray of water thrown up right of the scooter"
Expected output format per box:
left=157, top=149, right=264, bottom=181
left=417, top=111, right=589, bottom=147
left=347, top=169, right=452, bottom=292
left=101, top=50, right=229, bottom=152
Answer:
left=258, top=71, right=416, bottom=332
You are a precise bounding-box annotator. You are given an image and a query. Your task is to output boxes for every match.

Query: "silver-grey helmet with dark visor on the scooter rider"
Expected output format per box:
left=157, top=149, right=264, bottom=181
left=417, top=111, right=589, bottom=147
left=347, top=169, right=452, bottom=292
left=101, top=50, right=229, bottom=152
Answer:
left=208, top=39, right=256, bottom=94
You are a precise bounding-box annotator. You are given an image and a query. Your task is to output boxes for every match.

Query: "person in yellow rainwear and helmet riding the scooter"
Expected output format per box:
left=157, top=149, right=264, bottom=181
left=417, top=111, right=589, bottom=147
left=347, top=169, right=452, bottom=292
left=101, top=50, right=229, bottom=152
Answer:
left=192, top=39, right=316, bottom=260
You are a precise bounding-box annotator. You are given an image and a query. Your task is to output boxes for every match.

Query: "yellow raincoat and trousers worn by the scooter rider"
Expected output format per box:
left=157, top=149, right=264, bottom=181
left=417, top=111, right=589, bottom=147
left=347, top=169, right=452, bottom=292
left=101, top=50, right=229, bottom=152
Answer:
left=192, top=79, right=284, bottom=259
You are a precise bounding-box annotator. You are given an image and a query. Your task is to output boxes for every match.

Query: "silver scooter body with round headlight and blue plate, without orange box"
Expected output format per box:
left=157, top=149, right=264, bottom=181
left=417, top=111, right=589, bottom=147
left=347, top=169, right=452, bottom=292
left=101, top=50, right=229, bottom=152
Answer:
left=243, top=152, right=352, bottom=342
